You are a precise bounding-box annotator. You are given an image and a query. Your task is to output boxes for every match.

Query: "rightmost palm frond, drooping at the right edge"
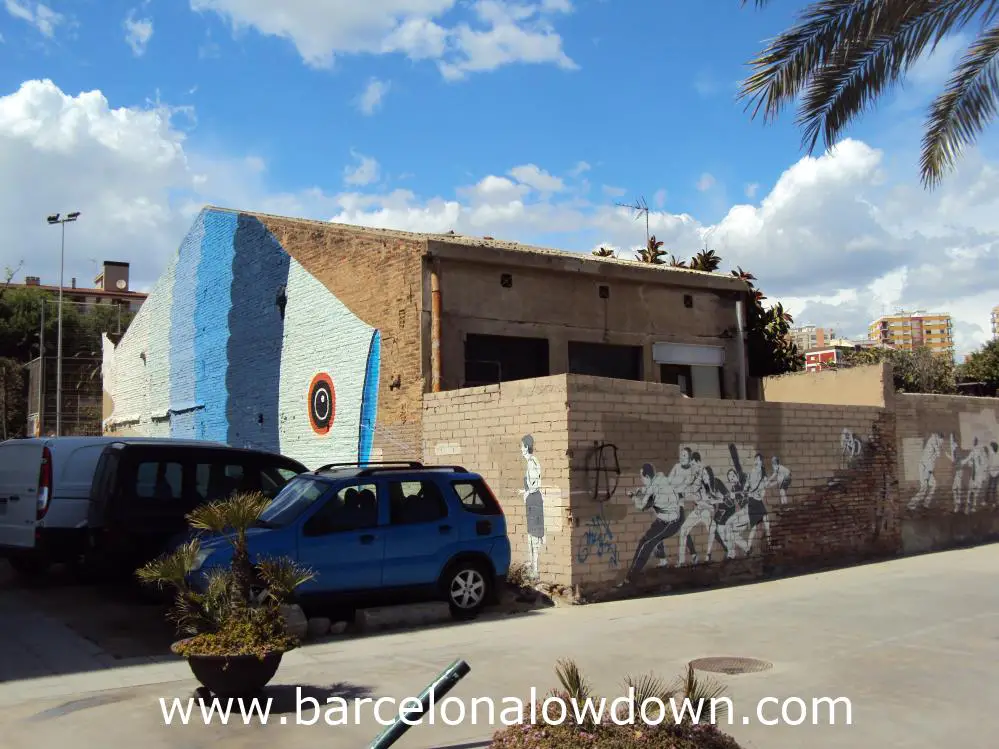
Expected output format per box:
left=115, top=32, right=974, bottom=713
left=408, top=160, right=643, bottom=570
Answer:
left=920, top=25, right=999, bottom=187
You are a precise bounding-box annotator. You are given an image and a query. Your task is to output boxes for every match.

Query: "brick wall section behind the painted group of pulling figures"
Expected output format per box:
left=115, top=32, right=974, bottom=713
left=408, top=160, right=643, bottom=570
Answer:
left=568, top=376, right=899, bottom=595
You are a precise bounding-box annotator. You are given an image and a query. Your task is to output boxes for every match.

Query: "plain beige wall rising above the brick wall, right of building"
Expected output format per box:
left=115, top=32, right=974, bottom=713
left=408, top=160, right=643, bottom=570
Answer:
left=763, top=364, right=894, bottom=408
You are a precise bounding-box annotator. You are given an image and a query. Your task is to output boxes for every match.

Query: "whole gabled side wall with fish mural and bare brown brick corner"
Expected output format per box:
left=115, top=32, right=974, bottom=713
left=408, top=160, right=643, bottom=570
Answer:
left=104, top=208, right=423, bottom=467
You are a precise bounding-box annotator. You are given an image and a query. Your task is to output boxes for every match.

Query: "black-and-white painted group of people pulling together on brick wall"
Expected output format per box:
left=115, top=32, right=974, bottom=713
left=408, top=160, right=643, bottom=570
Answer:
left=619, top=444, right=791, bottom=587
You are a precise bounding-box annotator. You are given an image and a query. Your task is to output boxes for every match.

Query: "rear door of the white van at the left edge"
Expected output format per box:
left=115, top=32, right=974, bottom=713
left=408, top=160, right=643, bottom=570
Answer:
left=0, top=440, right=47, bottom=549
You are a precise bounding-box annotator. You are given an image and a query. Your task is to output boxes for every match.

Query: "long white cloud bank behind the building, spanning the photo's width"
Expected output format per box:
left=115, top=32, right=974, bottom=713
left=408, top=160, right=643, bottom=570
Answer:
left=7, top=81, right=999, bottom=360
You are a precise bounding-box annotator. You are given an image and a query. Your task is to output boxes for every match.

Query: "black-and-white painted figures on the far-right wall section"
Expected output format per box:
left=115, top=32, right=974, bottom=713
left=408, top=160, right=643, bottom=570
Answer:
left=905, top=410, right=999, bottom=514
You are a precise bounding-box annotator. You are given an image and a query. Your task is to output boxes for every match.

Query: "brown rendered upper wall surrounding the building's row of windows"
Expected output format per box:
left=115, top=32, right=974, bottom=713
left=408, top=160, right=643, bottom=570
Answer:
left=440, top=250, right=738, bottom=398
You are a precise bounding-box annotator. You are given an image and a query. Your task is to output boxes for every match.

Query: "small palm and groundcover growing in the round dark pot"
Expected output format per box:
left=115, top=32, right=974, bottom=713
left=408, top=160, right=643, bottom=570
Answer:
left=136, top=493, right=313, bottom=658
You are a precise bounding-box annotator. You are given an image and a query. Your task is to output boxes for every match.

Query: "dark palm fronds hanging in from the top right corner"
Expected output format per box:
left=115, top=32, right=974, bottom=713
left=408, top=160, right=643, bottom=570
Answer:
left=740, top=0, right=999, bottom=187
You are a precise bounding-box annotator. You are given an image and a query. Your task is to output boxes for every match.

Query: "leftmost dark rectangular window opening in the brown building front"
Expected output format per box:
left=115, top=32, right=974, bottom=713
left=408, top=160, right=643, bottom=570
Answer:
left=465, top=335, right=550, bottom=387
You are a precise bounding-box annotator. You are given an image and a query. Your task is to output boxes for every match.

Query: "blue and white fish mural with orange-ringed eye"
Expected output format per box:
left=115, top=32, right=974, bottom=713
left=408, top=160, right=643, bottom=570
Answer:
left=103, top=209, right=381, bottom=467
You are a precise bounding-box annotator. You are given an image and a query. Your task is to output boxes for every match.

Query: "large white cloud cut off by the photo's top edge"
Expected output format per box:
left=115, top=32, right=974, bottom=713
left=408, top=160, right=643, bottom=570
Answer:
left=190, top=0, right=577, bottom=80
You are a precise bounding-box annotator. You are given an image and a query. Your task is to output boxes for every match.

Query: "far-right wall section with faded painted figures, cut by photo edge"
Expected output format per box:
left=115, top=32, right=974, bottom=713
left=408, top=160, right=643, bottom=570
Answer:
left=895, top=393, right=999, bottom=553
